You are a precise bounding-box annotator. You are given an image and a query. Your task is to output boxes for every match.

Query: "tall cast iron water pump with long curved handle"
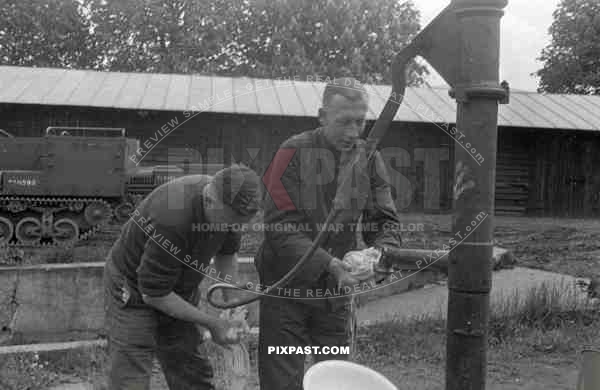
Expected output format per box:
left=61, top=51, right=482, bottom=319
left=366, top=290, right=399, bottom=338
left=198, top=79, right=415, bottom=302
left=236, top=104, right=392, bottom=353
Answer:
left=208, top=0, right=508, bottom=390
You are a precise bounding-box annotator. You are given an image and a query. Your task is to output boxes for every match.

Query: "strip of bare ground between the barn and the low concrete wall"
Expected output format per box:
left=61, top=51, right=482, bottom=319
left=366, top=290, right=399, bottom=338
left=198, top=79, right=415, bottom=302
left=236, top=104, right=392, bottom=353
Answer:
left=0, top=214, right=600, bottom=278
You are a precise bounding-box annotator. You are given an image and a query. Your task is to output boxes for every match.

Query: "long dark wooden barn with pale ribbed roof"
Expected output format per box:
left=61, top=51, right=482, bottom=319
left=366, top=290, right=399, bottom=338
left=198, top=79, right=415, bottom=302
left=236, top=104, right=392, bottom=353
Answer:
left=0, top=66, right=600, bottom=217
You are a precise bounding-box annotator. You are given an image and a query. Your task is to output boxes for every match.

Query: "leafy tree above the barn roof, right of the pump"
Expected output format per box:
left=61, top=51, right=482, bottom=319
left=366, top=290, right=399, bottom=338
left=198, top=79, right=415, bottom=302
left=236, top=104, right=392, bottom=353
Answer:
left=536, top=0, right=600, bottom=95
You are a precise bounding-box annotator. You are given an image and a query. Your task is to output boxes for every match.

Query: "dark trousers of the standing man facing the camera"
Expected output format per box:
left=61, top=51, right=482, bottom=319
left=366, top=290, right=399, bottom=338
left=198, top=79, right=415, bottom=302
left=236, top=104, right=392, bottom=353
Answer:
left=258, top=297, right=352, bottom=390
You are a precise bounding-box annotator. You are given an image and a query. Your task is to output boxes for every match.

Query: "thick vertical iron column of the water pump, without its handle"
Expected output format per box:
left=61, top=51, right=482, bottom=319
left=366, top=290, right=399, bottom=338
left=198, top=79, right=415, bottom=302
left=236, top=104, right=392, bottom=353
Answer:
left=446, top=0, right=507, bottom=390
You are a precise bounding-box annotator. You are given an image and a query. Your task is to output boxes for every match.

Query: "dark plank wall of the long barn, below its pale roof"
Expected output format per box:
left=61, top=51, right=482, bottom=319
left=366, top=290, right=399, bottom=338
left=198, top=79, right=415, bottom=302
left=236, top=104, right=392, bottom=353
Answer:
left=0, top=104, right=600, bottom=216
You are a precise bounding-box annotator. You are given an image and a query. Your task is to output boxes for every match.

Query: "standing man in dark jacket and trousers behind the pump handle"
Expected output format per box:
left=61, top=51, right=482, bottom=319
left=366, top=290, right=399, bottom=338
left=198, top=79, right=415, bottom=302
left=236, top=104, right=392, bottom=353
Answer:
left=255, top=78, right=401, bottom=390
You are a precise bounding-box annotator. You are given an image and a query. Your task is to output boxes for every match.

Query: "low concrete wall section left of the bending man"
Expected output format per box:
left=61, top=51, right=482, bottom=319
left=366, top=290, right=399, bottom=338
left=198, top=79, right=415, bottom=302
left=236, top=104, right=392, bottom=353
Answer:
left=0, top=263, right=104, bottom=342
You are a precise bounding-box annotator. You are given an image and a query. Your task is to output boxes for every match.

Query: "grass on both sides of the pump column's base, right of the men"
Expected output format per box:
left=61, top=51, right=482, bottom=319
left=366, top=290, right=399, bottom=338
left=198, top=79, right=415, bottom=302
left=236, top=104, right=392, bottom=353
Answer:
left=355, top=284, right=600, bottom=389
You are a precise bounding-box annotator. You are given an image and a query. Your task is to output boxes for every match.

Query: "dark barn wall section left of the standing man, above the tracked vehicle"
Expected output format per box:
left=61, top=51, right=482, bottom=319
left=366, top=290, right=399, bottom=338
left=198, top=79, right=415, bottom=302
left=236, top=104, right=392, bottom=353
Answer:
left=0, top=105, right=317, bottom=171
